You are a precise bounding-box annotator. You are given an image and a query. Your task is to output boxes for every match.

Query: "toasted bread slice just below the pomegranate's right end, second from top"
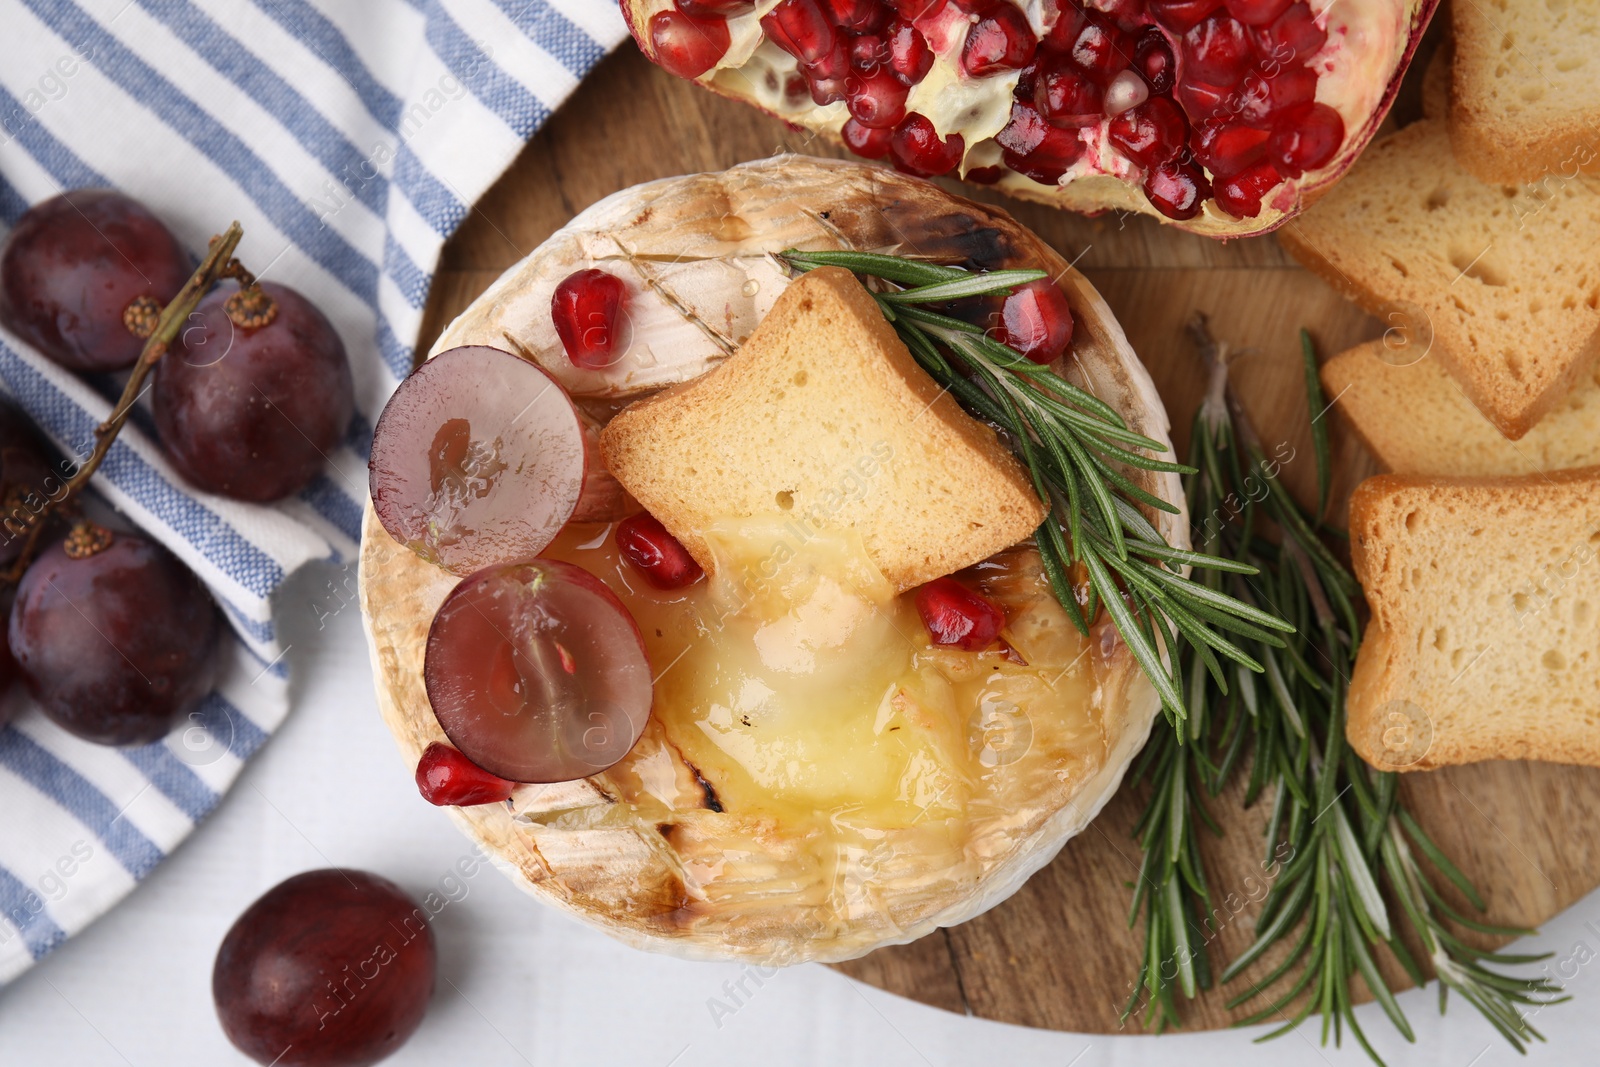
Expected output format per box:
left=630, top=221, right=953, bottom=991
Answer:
left=1282, top=120, right=1600, bottom=438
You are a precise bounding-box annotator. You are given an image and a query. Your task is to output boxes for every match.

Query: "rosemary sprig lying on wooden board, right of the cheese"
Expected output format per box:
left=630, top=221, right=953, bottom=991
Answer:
left=1125, top=320, right=1565, bottom=1061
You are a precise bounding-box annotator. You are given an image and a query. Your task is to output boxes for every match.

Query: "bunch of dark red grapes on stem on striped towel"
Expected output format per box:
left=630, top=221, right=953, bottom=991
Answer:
left=0, top=189, right=354, bottom=745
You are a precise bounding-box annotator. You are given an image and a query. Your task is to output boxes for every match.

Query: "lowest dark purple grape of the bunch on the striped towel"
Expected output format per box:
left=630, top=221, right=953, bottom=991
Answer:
left=8, top=531, right=222, bottom=745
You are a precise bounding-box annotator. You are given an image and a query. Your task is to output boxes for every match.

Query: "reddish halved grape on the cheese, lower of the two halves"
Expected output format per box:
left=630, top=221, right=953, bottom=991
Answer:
left=422, top=560, right=651, bottom=782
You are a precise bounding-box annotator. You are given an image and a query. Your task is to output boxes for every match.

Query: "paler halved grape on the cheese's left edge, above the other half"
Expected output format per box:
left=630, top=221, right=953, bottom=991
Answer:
left=370, top=346, right=598, bottom=574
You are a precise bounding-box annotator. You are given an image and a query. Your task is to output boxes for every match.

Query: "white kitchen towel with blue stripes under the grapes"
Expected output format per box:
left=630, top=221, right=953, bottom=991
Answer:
left=0, top=0, right=626, bottom=982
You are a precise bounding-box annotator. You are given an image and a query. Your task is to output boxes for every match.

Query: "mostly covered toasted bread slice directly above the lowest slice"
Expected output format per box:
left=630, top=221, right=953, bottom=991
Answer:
left=1322, top=341, right=1600, bottom=477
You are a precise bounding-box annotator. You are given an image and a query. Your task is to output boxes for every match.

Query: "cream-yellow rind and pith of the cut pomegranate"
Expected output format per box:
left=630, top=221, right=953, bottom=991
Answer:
left=621, top=0, right=1438, bottom=240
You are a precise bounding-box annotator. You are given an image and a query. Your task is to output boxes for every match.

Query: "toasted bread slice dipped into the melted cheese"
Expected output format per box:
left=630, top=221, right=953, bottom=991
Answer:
left=600, top=267, right=1045, bottom=592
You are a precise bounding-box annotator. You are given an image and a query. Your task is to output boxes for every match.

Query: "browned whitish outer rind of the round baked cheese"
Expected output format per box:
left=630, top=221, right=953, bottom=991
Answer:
left=360, top=155, right=1189, bottom=966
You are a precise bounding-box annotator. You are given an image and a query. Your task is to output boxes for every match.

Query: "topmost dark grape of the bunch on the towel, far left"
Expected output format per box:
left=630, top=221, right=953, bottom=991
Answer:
left=0, top=189, right=190, bottom=371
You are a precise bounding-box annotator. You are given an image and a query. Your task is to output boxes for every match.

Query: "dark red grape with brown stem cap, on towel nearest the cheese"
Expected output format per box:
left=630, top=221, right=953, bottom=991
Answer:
left=152, top=282, right=355, bottom=502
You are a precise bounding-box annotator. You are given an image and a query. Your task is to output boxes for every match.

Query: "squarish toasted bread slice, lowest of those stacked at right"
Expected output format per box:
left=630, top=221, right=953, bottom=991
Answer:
left=1347, top=467, right=1600, bottom=771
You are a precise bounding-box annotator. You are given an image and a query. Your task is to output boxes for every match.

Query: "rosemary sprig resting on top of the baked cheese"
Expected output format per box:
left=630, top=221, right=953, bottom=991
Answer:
left=781, top=250, right=1293, bottom=723
